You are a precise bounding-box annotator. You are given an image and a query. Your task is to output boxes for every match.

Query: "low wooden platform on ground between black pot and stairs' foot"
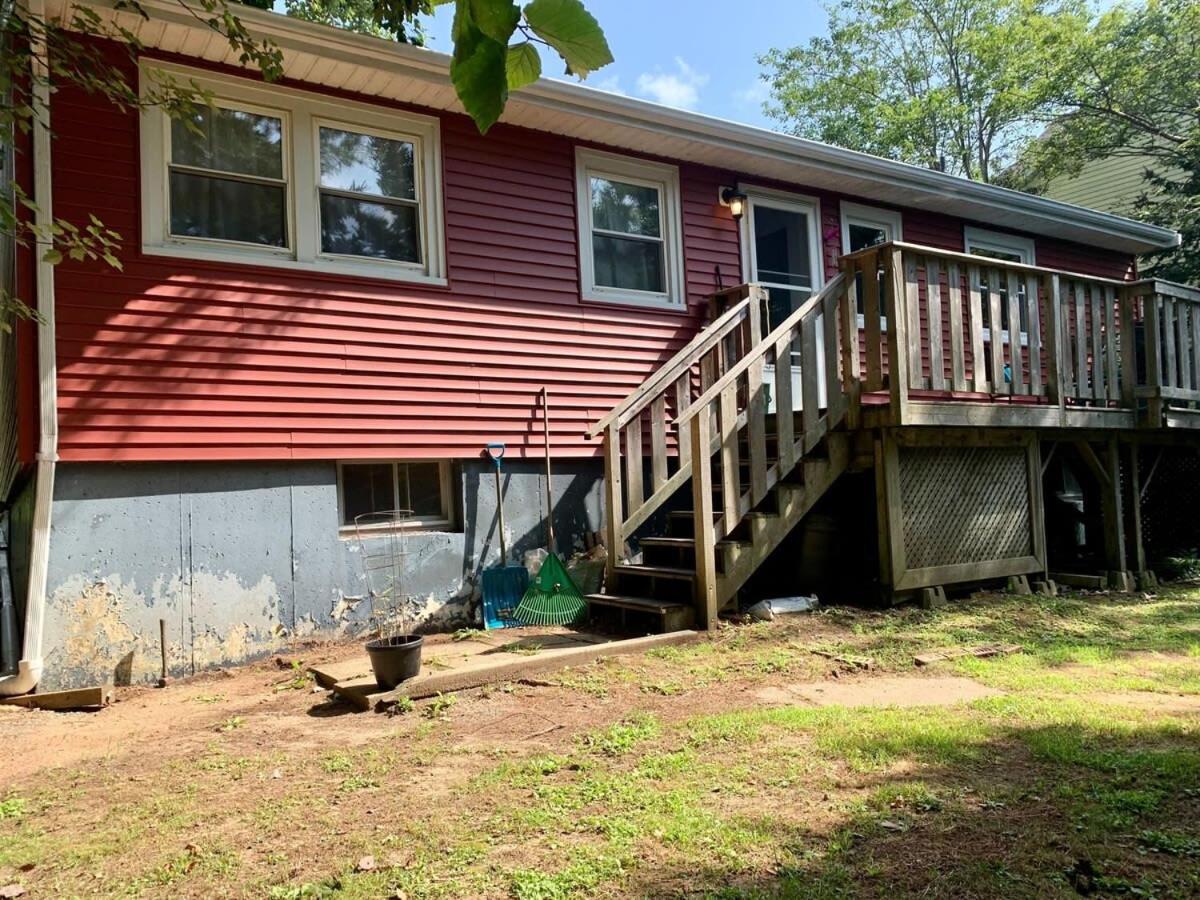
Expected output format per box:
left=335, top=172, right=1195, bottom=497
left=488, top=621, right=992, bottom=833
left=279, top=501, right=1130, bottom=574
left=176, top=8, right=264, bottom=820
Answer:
left=310, top=631, right=698, bottom=710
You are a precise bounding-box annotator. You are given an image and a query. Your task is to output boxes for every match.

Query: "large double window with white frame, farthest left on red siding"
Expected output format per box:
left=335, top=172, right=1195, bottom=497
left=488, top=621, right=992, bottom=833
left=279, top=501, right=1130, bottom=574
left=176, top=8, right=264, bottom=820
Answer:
left=142, top=62, right=445, bottom=284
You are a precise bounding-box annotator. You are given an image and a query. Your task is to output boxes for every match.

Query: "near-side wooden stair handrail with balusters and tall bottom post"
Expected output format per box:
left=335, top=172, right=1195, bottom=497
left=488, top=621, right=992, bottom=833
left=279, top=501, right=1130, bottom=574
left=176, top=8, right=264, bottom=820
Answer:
left=676, top=274, right=857, bottom=628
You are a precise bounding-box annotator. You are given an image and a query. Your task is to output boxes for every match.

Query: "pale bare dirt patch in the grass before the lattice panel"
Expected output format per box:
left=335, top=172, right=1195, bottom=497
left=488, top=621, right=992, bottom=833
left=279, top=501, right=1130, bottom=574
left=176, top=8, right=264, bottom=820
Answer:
left=755, top=676, right=1003, bottom=707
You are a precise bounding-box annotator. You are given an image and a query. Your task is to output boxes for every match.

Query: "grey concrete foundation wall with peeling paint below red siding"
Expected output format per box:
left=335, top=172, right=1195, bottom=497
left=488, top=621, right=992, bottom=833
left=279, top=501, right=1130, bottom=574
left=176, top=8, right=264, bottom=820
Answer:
left=34, top=461, right=602, bottom=690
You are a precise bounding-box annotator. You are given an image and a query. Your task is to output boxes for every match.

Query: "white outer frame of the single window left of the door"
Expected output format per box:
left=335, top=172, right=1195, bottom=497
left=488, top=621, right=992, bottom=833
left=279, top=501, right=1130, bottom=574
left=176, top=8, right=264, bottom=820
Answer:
left=575, top=148, right=688, bottom=312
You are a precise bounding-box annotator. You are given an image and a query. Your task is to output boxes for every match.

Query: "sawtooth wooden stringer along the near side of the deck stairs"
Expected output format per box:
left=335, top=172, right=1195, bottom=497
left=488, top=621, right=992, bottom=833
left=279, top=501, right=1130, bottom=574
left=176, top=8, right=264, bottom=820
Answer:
left=716, top=432, right=850, bottom=608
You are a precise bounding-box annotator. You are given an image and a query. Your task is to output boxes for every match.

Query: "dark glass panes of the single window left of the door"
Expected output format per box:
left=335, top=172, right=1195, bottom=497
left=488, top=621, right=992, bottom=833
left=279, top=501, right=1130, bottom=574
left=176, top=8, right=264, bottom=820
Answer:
left=588, top=175, right=667, bottom=294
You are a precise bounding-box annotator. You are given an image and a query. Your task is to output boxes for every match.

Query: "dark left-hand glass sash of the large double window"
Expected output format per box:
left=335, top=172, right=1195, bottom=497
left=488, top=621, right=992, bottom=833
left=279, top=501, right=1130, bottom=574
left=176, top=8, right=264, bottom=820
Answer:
left=168, top=107, right=289, bottom=247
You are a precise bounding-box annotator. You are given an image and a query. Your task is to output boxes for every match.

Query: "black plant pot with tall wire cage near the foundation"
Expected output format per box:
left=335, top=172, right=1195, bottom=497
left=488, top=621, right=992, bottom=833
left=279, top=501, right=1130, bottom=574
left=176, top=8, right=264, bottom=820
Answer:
left=354, top=510, right=424, bottom=690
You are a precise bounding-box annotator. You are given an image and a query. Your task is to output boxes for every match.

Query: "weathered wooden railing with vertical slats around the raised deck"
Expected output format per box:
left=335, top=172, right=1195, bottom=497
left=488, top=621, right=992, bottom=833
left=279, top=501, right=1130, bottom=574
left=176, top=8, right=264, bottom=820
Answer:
left=841, top=242, right=1200, bottom=424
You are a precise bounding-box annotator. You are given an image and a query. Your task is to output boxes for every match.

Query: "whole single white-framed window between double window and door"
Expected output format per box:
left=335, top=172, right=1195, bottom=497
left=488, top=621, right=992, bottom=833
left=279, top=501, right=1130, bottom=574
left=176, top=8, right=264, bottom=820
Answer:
left=576, top=150, right=685, bottom=308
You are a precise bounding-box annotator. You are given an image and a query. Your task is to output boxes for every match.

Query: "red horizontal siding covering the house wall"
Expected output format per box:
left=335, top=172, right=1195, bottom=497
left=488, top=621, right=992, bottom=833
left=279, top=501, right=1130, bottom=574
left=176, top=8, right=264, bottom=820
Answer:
left=54, top=37, right=1123, bottom=461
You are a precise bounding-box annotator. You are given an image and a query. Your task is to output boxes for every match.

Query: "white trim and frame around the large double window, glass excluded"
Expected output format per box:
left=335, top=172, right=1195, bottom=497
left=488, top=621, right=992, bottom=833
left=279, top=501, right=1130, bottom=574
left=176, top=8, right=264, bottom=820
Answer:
left=139, top=60, right=448, bottom=286
